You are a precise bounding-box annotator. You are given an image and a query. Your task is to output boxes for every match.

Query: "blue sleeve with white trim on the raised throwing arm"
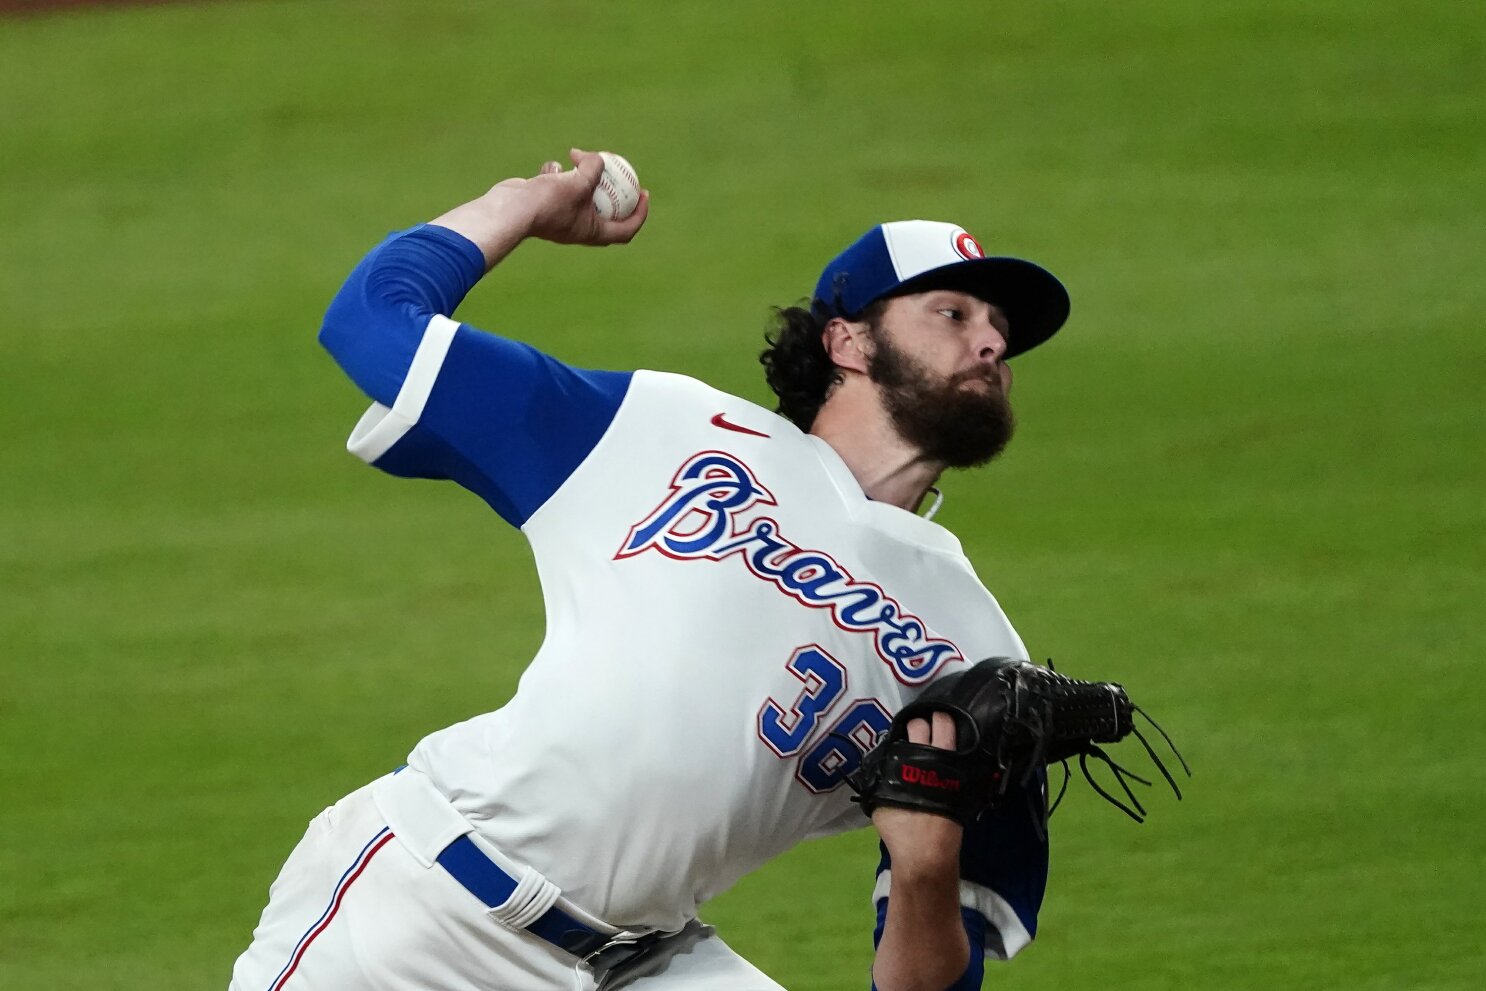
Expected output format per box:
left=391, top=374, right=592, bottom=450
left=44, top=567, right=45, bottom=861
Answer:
left=319, top=224, right=632, bottom=526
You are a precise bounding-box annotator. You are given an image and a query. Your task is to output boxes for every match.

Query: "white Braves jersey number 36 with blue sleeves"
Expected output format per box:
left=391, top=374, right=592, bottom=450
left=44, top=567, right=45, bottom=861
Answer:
left=321, top=226, right=1046, bottom=955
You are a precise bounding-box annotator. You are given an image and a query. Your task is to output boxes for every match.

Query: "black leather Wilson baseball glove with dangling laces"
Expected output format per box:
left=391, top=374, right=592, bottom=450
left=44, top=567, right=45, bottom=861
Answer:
left=847, top=657, right=1192, bottom=823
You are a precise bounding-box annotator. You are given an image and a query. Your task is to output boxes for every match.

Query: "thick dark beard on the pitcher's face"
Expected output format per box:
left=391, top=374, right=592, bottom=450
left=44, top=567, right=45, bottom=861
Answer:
left=866, top=325, right=1016, bottom=468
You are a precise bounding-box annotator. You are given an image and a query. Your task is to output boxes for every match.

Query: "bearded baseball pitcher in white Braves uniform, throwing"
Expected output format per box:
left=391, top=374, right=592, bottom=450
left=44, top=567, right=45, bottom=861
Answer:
left=232, top=152, right=1182, bottom=991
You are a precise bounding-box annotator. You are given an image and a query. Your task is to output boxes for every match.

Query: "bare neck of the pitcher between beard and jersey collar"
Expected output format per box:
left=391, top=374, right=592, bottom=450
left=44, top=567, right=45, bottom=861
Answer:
left=810, top=382, right=944, bottom=513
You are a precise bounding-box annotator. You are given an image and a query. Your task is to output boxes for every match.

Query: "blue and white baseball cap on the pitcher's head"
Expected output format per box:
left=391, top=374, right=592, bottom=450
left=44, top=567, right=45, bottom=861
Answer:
left=811, top=220, right=1068, bottom=358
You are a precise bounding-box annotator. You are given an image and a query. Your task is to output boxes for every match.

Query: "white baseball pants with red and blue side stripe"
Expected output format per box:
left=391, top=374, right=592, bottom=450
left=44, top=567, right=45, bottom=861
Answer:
left=230, top=784, right=783, bottom=991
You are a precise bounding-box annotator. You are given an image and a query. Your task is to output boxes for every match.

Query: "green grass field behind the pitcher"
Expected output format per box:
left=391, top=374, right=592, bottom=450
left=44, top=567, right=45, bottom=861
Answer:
left=0, top=0, right=1486, bottom=991
